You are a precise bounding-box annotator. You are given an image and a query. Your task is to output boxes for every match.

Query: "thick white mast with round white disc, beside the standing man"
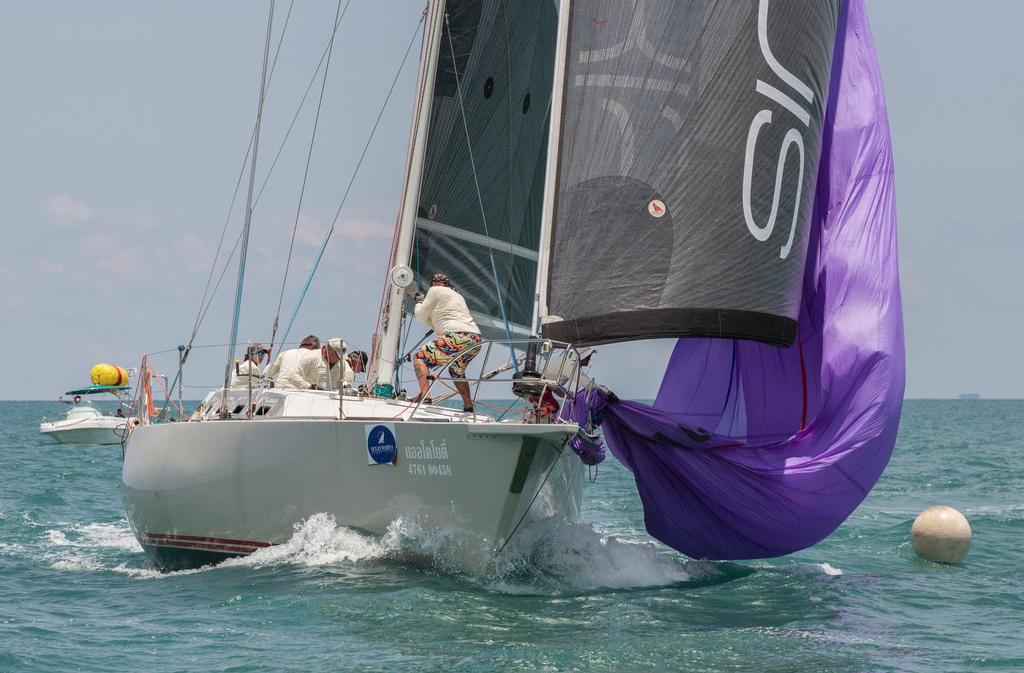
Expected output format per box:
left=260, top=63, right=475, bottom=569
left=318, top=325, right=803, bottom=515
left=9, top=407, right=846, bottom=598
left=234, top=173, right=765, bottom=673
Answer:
left=369, top=0, right=444, bottom=395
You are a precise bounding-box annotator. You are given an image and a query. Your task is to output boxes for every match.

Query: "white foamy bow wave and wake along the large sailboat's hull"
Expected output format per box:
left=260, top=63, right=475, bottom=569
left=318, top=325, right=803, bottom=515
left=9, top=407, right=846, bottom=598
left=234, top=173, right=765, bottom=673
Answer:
left=34, top=513, right=842, bottom=595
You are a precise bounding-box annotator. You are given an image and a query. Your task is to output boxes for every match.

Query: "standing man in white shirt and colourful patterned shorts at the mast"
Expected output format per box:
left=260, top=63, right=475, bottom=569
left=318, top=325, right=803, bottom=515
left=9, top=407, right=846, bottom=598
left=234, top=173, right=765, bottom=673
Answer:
left=413, top=274, right=480, bottom=412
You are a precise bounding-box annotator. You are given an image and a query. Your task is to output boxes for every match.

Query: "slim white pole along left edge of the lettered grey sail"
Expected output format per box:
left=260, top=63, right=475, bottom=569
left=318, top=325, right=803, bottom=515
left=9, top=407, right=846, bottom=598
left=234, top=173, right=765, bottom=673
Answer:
left=534, top=0, right=572, bottom=334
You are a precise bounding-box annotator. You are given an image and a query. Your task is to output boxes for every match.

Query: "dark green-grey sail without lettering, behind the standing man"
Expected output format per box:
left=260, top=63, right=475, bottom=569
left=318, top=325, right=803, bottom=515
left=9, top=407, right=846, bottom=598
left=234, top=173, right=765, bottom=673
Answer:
left=411, top=0, right=557, bottom=338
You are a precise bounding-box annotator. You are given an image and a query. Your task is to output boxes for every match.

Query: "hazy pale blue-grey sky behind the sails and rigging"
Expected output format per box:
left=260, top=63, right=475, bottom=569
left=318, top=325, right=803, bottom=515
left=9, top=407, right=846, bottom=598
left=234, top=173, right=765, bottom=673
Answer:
left=0, top=0, right=1024, bottom=399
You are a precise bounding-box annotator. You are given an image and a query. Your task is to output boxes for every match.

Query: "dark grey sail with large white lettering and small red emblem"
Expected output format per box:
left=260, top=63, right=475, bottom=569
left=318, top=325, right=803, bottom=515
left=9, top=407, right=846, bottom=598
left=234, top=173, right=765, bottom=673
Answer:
left=542, top=0, right=840, bottom=345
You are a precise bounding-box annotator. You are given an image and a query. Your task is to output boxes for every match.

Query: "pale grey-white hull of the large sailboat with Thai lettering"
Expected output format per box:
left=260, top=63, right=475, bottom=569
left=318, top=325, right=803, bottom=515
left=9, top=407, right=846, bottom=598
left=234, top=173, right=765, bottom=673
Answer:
left=123, top=395, right=584, bottom=569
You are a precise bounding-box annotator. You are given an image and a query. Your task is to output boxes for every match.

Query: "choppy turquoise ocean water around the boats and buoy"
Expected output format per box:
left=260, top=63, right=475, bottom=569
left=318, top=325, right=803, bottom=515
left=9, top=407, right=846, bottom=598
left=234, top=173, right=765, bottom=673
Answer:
left=0, top=401, right=1024, bottom=673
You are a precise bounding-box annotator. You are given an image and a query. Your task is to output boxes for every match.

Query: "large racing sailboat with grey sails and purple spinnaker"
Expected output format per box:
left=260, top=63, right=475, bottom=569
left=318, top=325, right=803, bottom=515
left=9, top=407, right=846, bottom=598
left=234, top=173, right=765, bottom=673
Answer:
left=123, top=0, right=902, bottom=569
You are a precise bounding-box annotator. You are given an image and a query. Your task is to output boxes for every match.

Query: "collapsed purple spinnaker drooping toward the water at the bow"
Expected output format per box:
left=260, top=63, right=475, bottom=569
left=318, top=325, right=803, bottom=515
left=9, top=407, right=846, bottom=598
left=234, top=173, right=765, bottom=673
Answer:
left=577, top=0, right=904, bottom=559
